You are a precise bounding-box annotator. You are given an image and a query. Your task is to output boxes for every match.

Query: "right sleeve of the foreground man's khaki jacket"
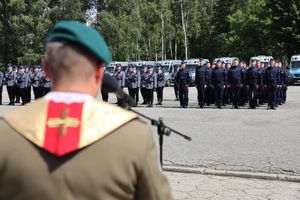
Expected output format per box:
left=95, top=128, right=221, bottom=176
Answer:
left=135, top=129, right=173, bottom=200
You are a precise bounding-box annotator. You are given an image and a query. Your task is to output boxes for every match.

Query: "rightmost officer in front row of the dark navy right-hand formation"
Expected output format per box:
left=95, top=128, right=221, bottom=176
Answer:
left=264, top=59, right=278, bottom=110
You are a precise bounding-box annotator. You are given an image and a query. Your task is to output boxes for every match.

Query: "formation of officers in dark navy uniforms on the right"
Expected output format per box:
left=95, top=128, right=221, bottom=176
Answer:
left=175, top=59, right=288, bottom=110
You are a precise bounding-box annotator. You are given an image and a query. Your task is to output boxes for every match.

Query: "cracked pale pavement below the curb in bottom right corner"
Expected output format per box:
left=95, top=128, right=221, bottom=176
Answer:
left=165, top=172, right=300, bottom=200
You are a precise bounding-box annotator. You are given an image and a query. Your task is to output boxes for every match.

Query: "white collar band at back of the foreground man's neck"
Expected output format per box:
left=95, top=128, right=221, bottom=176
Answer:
left=45, top=92, right=95, bottom=104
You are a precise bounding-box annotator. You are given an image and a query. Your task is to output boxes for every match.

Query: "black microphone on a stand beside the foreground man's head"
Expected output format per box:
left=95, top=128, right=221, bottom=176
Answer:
left=101, top=73, right=136, bottom=109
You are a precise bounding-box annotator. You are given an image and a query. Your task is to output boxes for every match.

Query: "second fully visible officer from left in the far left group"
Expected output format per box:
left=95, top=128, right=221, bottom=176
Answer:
left=16, top=66, right=29, bottom=105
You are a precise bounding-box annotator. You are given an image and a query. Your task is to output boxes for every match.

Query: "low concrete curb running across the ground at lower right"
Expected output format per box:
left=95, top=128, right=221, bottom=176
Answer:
left=163, top=166, right=300, bottom=183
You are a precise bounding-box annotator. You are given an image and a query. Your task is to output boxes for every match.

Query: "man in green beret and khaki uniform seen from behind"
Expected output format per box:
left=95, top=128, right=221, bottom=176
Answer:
left=0, top=22, right=172, bottom=200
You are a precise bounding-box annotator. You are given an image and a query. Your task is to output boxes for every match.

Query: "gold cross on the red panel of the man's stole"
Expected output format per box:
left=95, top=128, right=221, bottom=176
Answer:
left=47, top=108, right=80, bottom=136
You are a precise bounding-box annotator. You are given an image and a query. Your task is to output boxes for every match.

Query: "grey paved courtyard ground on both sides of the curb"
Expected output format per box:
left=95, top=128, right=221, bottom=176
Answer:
left=0, top=86, right=300, bottom=200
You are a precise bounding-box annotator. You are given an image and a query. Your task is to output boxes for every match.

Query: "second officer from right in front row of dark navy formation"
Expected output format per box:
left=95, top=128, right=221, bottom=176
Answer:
left=246, top=60, right=259, bottom=109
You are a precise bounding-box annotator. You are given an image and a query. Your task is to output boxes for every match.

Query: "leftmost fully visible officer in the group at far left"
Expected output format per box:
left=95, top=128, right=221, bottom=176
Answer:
left=5, top=65, right=16, bottom=106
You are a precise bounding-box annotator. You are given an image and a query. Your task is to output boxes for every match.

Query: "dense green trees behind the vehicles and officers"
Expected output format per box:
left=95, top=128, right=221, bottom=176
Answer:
left=0, top=0, right=300, bottom=65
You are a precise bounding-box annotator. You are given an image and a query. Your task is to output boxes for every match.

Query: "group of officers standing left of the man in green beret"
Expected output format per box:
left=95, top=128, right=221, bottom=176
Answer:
left=0, top=65, right=52, bottom=105
